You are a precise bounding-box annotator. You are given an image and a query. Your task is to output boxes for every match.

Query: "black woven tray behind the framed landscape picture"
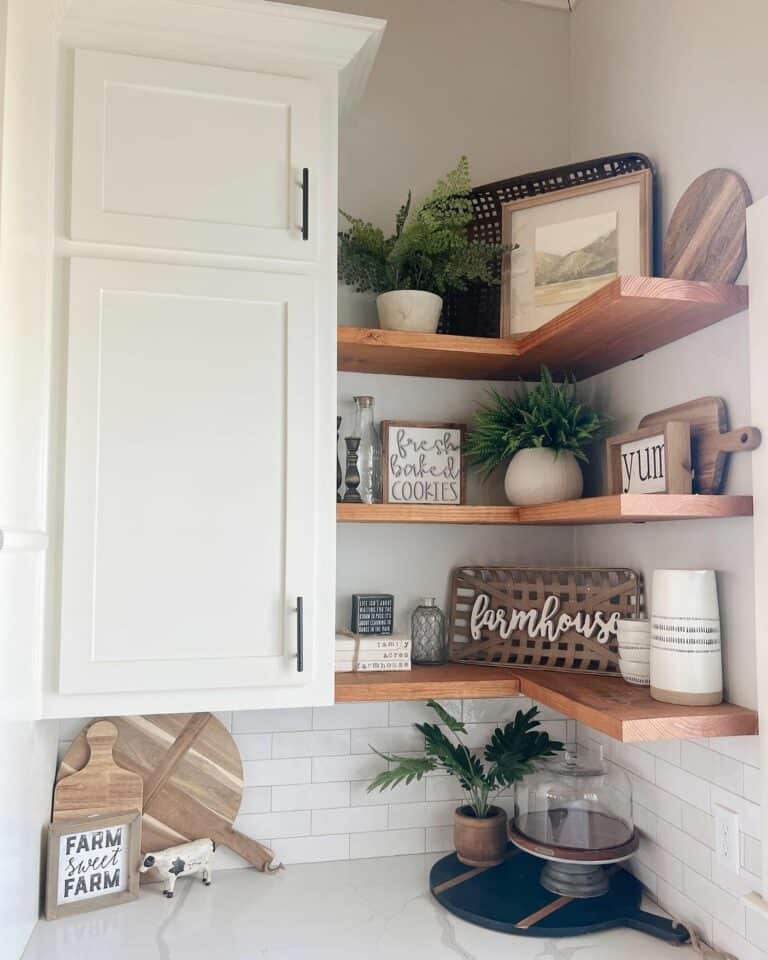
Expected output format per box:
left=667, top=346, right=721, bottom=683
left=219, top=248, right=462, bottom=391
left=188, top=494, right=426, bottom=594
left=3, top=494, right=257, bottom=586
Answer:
left=438, top=153, right=652, bottom=337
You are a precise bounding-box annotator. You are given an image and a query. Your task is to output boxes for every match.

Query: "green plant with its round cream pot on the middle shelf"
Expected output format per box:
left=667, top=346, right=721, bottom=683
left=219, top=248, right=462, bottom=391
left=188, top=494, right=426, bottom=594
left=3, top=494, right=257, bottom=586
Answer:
left=464, top=366, right=607, bottom=506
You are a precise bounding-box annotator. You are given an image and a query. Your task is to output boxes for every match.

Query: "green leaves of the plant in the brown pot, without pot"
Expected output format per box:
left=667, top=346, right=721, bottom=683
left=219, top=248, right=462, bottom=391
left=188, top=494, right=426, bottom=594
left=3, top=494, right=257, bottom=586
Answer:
left=368, top=700, right=563, bottom=817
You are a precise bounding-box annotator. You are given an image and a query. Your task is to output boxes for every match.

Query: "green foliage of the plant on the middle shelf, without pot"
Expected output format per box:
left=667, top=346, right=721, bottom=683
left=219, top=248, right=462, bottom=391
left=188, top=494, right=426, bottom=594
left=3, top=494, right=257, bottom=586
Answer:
left=464, top=366, right=608, bottom=478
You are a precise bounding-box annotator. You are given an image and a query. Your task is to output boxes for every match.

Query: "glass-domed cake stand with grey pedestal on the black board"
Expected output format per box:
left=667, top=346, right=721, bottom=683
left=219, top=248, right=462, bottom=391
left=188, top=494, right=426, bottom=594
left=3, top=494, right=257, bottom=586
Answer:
left=509, top=747, right=637, bottom=897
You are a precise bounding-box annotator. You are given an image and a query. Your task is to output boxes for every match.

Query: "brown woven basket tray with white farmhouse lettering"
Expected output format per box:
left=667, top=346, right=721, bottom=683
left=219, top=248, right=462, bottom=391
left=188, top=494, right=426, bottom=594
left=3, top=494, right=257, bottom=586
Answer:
left=450, top=567, right=642, bottom=673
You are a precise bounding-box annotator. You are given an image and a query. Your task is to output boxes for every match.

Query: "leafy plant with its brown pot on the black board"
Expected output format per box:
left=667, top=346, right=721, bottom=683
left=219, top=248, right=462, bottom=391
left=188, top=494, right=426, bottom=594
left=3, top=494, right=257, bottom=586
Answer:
left=368, top=700, right=563, bottom=867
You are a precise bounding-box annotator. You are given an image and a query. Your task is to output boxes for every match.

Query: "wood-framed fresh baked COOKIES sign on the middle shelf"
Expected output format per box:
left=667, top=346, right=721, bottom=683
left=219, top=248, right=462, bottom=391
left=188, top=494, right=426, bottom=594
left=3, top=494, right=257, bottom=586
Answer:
left=381, top=420, right=466, bottom=505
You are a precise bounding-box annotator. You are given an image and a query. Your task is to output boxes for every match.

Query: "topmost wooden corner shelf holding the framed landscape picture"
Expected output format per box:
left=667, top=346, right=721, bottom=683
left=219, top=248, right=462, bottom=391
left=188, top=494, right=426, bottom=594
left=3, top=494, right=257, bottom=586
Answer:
left=338, top=275, right=749, bottom=380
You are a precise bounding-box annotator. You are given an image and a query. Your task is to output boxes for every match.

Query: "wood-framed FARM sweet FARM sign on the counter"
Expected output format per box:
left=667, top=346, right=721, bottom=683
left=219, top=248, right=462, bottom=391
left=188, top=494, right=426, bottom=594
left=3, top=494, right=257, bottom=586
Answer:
left=45, top=811, right=141, bottom=920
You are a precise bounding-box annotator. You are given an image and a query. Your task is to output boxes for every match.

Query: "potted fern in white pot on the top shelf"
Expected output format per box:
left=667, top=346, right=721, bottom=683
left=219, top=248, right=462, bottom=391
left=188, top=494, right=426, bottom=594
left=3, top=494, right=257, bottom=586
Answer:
left=339, top=157, right=505, bottom=333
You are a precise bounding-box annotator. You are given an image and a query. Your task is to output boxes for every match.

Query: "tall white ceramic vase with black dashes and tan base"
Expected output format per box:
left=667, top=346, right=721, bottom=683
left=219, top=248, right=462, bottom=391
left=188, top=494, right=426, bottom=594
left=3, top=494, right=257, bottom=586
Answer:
left=651, top=570, right=723, bottom=705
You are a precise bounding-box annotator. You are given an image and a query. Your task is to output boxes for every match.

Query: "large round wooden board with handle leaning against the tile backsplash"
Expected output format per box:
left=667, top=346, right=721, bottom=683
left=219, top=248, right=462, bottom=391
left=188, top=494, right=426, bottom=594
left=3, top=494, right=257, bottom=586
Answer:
left=56, top=713, right=274, bottom=870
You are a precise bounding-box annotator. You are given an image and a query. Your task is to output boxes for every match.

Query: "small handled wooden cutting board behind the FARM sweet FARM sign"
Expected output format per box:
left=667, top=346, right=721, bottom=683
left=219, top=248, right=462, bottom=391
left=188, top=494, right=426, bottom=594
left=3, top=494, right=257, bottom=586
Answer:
left=53, top=720, right=144, bottom=821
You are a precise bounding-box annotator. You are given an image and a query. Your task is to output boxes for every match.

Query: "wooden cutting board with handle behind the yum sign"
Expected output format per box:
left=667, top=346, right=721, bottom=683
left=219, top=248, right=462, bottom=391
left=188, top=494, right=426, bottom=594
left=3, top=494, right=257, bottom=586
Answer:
left=640, top=397, right=762, bottom=493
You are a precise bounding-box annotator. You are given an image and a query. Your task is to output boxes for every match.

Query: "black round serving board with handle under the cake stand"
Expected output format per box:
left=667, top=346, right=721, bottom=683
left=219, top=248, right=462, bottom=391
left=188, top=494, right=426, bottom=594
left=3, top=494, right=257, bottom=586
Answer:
left=429, top=846, right=688, bottom=944
